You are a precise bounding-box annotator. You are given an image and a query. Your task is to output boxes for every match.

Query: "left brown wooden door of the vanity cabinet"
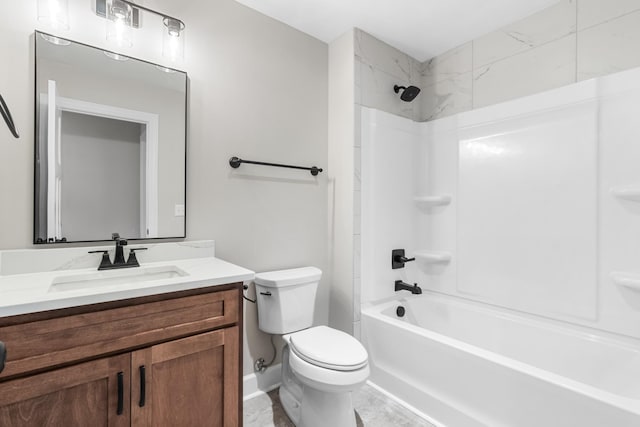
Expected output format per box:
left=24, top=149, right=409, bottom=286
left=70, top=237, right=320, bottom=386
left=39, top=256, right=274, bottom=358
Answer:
left=0, top=354, right=131, bottom=427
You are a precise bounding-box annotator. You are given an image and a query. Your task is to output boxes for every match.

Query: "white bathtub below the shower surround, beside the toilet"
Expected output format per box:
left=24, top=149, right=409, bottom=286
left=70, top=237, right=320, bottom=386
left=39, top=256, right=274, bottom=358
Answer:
left=361, top=292, right=640, bottom=427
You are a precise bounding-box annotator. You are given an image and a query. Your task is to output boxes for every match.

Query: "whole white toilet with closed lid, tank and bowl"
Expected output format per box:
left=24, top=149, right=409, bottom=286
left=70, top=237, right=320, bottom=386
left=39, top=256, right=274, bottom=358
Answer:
left=255, top=267, right=369, bottom=427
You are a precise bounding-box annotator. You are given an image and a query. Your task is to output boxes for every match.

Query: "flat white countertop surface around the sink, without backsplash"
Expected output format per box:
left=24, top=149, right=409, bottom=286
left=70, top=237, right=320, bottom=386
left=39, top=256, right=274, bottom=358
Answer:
left=0, top=257, right=254, bottom=317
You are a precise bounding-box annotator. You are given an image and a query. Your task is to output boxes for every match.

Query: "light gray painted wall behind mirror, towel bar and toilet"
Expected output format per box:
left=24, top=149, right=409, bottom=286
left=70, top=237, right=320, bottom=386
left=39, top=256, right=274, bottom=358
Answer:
left=0, top=0, right=331, bottom=373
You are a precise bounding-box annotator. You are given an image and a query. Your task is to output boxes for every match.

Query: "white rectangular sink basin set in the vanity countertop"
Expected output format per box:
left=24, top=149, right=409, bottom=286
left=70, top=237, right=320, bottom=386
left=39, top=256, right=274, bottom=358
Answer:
left=49, top=265, right=188, bottom=292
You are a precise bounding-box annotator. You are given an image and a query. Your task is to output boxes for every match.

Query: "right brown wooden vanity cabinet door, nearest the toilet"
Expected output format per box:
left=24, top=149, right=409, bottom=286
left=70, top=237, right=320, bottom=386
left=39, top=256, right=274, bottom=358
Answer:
left=131, top=326, right=240, bottom=427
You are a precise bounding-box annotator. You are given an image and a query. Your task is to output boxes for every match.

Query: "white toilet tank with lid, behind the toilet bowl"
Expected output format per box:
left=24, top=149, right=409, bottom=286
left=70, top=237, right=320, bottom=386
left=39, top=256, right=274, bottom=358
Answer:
left=254, top=267, right=322, bottom=334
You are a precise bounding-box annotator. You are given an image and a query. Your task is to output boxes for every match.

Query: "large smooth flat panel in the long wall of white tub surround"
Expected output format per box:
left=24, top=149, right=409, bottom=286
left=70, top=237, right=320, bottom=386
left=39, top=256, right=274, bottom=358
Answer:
left=458, top=96, right=596, bottom=320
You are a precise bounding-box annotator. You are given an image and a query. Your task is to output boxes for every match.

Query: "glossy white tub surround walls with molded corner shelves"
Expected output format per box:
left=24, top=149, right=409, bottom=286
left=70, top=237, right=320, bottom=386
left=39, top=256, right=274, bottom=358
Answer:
left=361, top=69, right=640, bottom=338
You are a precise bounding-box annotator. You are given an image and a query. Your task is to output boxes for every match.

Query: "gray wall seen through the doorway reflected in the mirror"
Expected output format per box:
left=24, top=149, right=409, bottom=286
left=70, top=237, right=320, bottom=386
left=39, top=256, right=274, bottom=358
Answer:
left=60, top=111, right=141, bottom=241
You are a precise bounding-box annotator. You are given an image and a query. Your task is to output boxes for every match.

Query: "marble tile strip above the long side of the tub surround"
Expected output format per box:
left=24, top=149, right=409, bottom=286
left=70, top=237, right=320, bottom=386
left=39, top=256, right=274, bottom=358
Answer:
left=418, top=0, right=640, bottom=121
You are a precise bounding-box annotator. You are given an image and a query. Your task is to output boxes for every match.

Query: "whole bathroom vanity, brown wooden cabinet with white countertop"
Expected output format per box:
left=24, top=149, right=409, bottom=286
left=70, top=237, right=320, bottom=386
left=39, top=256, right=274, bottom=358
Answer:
left=0, top=244, right=253, bottom=427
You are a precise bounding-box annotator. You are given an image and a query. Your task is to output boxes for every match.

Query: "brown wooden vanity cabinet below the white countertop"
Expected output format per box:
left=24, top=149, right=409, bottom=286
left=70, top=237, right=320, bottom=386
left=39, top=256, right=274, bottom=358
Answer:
left=0, top=283, right=242, bottom=427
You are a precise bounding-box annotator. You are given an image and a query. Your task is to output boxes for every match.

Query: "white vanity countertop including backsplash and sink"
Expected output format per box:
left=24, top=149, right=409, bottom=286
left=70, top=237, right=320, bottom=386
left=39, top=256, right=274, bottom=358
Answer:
left=0, top=241, right=253, bottom=316
